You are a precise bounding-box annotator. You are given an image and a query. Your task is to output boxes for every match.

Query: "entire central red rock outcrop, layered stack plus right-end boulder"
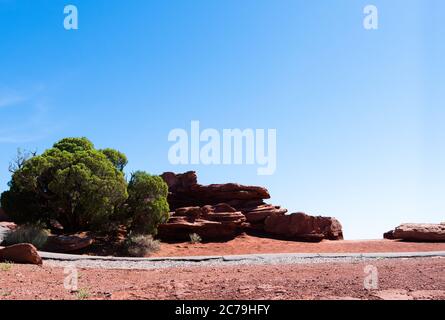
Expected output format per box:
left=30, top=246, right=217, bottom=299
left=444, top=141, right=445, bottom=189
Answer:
left=158, top=171, right=343, bottom=241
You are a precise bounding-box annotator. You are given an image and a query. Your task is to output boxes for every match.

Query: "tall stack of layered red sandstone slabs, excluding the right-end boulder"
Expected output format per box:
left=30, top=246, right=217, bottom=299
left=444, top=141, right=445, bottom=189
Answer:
left=158, top=171, right=287, bottom=240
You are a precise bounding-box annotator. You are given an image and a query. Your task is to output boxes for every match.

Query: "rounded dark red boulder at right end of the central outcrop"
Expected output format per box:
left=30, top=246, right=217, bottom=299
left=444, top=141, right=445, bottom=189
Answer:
left=265, top=213, right=343, bottom=241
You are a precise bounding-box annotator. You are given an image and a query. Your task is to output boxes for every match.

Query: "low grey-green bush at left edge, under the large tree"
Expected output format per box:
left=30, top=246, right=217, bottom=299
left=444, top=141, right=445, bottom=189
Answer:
left=3, top=224, right=49, bottom=249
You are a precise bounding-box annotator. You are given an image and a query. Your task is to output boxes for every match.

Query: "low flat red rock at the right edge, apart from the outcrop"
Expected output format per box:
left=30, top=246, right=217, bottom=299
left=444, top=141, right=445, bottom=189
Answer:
left=392, top=223, right=445, bottom=242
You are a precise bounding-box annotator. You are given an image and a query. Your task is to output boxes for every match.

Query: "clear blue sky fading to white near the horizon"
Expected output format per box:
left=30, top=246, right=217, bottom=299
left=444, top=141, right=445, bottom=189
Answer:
left=0, top=0, right=445, bottom=239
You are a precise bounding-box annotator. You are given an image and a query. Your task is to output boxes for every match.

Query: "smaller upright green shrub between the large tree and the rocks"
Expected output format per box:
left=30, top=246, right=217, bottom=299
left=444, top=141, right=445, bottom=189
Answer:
left=126, top=171, right=169, bottom=235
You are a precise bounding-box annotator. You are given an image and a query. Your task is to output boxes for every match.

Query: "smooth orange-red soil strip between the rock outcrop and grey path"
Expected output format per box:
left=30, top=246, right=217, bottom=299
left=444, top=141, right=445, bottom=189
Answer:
left=153, top=235, right=445, bottom=257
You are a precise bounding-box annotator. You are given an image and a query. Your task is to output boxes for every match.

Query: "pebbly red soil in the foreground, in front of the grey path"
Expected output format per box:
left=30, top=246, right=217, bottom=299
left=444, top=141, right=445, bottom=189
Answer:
left=0, top=258, right=445, bottom=300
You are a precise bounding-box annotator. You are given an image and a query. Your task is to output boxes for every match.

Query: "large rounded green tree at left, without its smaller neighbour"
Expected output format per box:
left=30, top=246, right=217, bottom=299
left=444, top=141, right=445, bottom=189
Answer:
left=0, top=138, right=128, bottom=231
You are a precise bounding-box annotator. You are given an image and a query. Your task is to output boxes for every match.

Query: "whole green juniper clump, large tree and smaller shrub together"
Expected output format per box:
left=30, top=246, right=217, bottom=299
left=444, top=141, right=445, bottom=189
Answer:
left=0, top=138, right=169, bottom=234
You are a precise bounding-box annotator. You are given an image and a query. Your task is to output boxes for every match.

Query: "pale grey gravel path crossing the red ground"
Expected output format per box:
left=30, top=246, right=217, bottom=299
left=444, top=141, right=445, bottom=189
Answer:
left=41, top=252, right=445, bottom=270
